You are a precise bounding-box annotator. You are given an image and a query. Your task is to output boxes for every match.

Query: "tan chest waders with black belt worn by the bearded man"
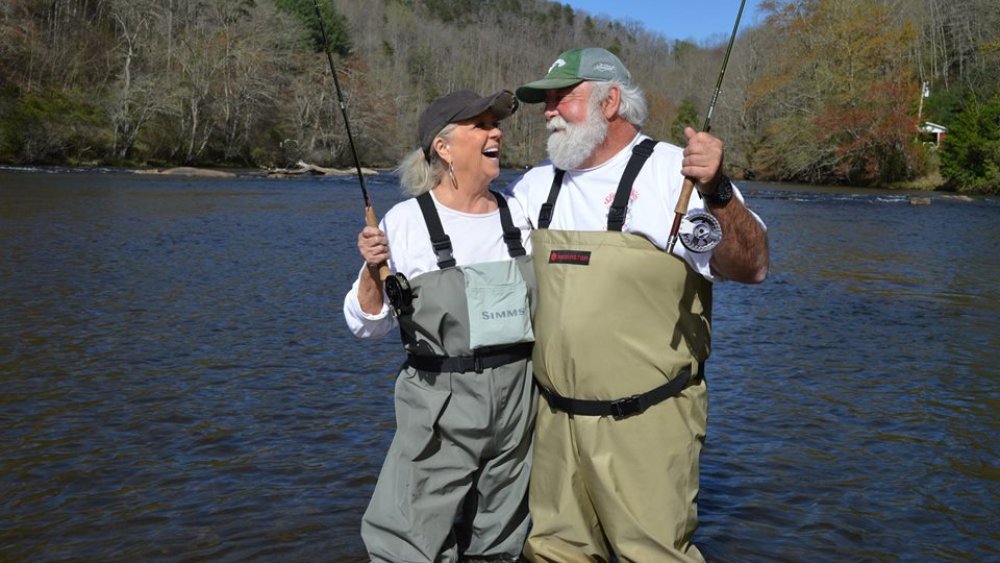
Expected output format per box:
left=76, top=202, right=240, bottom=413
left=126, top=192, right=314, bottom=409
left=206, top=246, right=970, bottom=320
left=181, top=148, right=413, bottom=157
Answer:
left=525, top=140, right=712, bottom=562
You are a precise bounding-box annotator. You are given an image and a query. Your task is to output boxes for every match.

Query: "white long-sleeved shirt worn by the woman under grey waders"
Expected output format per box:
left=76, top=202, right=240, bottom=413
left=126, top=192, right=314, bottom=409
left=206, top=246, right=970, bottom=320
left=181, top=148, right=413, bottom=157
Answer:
left=344, top=192, right=531, bottom=338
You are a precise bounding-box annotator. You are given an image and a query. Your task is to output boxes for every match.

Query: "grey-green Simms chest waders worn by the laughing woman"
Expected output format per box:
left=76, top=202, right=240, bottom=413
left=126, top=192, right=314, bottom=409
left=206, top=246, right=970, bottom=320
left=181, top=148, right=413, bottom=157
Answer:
left=361, top=194, right=537, bottom=562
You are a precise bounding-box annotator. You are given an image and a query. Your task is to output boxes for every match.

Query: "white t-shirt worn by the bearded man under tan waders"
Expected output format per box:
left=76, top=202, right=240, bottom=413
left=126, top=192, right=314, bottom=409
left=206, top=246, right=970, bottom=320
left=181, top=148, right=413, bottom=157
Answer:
left=511, top=134, right=763, bottom=281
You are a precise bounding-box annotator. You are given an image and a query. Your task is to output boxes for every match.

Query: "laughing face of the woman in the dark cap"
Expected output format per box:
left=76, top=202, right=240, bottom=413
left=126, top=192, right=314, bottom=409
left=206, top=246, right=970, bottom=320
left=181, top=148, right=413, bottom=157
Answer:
left=442, top=111, right=503, bottom=187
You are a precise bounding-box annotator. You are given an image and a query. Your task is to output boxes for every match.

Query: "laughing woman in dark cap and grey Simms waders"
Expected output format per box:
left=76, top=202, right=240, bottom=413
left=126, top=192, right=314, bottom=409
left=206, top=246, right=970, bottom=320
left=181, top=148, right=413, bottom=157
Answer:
left=344, top=91, right=536, bottom=562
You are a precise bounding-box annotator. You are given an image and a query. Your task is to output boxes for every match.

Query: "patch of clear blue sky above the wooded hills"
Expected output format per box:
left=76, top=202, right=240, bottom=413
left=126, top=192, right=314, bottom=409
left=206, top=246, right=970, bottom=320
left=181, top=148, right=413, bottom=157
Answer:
left=560, top=0, right=760, bottom=43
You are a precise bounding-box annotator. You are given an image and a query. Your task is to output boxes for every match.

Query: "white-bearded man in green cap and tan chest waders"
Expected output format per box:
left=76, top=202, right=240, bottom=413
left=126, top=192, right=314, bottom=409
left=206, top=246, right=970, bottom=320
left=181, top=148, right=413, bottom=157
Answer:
left=512, top=48, right=768, bottom=563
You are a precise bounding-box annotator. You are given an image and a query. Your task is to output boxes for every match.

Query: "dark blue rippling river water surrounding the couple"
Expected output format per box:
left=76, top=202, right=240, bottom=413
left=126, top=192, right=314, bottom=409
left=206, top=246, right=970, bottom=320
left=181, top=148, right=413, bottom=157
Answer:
left=0, top=171, right=1000, bottom=562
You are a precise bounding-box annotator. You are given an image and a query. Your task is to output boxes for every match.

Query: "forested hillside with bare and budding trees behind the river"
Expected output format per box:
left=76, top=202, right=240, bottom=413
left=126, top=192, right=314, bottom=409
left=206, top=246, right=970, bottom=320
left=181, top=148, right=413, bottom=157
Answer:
left=0, top=0, right=1000, bottom=191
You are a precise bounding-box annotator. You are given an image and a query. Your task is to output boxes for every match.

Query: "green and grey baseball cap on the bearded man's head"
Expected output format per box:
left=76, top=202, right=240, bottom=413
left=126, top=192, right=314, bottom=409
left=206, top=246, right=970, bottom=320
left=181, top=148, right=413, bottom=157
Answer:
left=517, top=47, right=632, bottom=104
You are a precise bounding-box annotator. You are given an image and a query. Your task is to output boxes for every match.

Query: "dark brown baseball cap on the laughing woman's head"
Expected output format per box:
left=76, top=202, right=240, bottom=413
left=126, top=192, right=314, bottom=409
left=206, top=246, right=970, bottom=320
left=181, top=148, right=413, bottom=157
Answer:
left=417, top=90, right=518, bottom=160
